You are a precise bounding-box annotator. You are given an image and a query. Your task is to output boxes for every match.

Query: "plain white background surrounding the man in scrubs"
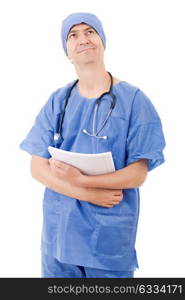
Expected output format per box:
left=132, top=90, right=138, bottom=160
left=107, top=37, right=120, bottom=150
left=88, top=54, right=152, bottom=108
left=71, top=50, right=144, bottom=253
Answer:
left=0, top=0, right=185, bottom=277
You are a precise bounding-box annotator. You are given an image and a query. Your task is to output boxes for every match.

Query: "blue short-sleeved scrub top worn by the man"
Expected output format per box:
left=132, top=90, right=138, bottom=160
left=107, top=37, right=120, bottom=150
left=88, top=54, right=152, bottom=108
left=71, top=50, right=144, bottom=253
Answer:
left=20, top=81, right=165, bottom=271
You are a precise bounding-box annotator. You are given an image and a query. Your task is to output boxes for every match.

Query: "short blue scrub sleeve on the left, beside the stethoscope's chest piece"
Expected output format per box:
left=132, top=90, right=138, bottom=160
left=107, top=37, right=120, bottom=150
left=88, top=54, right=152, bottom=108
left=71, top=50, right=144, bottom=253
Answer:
left=20, top=93, right=54, bottom=158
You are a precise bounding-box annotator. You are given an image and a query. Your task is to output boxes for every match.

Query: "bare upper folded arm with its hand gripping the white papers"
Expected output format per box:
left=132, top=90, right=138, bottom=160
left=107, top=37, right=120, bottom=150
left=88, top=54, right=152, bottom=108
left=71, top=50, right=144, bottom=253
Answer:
left=50, top=159, right=148, bottom=189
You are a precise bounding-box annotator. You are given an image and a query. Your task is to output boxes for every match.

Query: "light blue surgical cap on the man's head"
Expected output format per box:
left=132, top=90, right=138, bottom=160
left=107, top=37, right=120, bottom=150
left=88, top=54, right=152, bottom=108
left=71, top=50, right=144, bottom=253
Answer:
left=61, top=12, right=106, bottom=55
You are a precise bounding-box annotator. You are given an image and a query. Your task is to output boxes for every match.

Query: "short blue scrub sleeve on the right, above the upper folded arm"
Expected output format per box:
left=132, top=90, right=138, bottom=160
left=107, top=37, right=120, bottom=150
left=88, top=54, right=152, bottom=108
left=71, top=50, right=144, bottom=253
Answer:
left=126, top=90, right=166, bottom=171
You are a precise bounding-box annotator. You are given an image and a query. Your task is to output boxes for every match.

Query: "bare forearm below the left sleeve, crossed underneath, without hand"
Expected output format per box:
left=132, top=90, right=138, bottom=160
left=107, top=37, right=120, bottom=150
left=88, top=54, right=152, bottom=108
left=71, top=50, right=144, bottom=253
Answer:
left=31, top=163, right=87, bottom=200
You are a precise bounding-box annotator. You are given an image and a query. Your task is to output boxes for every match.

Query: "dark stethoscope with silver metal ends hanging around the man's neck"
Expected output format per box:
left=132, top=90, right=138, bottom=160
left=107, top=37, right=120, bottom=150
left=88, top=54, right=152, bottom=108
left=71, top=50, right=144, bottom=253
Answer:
left=54, top=72, right=116, bottom=147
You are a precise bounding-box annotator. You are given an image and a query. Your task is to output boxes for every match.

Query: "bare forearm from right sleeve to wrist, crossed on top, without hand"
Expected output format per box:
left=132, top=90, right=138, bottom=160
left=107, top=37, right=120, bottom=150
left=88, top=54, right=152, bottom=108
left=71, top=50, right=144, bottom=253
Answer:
left=80, top=159, right=148, bottom=189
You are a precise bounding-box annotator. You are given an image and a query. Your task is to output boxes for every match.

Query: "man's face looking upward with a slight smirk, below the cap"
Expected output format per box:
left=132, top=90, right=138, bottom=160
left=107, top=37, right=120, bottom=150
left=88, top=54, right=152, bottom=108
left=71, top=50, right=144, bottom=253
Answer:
left=66, top=24, right=104, bottom=65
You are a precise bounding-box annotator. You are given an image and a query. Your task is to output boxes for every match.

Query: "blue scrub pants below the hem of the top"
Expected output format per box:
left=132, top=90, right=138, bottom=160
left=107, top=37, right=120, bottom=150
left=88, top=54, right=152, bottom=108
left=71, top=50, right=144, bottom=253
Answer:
left=41, top=253, right=134, bottom=278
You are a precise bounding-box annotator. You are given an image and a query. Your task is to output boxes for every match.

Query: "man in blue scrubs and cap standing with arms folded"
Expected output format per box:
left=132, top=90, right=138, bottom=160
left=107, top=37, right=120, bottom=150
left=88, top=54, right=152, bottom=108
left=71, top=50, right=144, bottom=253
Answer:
left=20, top=13, right=165, bottom=278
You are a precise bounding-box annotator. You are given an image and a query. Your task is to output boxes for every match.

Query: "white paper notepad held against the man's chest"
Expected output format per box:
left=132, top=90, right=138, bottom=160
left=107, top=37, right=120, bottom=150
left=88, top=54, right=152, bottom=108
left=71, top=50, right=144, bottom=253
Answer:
left=48, top=146, right=115, bottom=175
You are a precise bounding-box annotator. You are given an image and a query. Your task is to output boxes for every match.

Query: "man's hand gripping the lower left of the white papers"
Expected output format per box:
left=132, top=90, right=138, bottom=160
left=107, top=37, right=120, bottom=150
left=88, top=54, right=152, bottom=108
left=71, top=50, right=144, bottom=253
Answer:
left=49, top=158, right=84, bottom=186
